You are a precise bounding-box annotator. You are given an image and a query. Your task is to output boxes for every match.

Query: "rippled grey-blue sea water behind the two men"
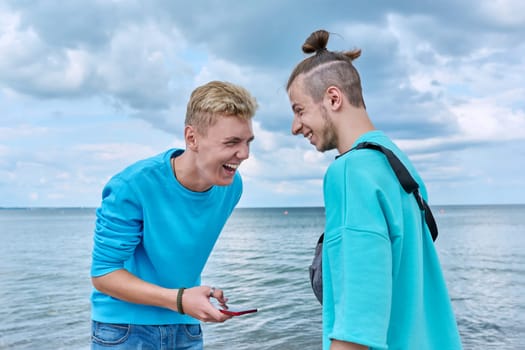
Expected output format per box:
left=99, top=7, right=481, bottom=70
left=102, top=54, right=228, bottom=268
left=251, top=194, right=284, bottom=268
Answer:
left=0, top=205, right=525, bottom=350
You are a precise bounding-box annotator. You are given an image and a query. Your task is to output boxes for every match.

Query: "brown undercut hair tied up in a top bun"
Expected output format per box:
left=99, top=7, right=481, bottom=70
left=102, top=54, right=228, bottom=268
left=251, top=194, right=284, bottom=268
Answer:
left=286, top=29, right=366, bottom=108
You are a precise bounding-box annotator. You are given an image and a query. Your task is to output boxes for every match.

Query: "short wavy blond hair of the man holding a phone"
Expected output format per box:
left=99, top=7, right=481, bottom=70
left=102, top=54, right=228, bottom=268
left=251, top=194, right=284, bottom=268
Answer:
left=184, top=81, right=258, bottom=135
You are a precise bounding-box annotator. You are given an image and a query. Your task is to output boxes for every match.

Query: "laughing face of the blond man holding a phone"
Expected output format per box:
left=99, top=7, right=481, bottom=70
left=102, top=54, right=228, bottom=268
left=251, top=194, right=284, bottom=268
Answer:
left=187, top=116, right=254, bottom=188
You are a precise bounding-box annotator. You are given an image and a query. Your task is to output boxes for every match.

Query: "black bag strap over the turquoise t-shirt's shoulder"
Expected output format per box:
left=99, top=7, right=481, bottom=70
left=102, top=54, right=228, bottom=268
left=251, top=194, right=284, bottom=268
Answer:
left=352, top=142, right=438, bottom=241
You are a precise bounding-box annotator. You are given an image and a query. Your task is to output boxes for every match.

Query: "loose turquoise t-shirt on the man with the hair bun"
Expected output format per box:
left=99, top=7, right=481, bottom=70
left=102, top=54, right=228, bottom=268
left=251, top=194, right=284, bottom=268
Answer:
left=323, top=131, right=461, bottom=350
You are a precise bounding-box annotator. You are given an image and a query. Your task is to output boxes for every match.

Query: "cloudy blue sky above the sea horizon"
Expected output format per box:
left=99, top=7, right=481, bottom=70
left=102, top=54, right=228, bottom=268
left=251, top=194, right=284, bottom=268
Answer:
left=0, top=0, right=525, bottom=207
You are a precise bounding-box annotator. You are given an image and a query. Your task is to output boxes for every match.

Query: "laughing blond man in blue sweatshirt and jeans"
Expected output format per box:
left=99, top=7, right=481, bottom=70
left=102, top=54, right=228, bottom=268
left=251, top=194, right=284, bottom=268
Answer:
left=91, top=81, right=257, bottom=350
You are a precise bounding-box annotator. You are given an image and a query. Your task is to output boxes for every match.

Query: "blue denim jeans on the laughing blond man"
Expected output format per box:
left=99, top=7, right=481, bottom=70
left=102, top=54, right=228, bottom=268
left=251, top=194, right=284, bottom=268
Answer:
left=91, top=321, right=203, bottom=350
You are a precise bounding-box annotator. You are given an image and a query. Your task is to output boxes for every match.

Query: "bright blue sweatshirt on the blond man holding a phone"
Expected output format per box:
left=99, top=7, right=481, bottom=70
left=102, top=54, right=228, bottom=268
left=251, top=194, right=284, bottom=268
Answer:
left=91, top=150, right=242, bottom=325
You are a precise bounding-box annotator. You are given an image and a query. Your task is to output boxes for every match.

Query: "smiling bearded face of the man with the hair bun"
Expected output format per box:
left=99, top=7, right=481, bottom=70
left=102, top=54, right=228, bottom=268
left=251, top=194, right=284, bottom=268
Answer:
left=288, top=77, right=338, bottom=152
